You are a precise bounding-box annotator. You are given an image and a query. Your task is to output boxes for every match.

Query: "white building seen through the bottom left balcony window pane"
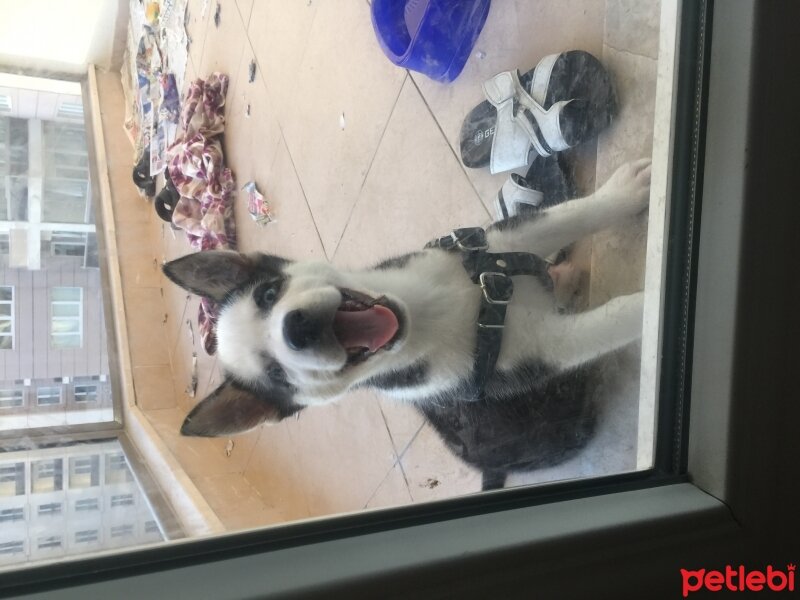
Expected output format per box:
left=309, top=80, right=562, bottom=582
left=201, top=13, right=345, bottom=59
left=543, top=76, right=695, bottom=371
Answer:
left=0, top=441, right=164, bottom=570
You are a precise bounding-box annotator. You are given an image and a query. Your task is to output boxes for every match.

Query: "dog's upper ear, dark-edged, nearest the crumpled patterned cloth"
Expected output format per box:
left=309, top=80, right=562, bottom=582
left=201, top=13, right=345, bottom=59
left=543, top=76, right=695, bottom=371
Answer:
left=163, top=250, right=257, bottom=302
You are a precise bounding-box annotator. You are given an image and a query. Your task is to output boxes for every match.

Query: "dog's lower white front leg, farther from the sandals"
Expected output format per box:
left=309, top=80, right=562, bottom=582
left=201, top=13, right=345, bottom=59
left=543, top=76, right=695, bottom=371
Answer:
left=542, top=292, right=643, bottom=370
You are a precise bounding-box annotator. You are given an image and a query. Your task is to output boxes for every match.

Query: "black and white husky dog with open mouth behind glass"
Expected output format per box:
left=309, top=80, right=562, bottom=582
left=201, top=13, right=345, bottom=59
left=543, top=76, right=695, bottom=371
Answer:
left=164, top=160, right=650, bottom=487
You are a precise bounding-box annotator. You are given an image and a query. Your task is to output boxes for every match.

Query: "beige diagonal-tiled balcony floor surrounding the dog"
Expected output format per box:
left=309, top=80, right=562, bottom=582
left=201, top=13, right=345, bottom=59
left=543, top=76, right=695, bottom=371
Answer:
left=144, top=0, right=659, bottom=527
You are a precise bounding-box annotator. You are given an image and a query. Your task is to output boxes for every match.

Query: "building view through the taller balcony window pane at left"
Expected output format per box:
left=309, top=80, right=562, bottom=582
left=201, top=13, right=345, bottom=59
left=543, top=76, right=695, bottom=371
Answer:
left=0, top=77, right=114, bottom=431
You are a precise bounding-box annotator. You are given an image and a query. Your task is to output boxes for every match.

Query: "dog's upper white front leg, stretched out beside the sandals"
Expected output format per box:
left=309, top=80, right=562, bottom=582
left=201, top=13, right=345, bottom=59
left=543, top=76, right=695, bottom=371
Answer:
left=488, top=159, right=650, bottom=256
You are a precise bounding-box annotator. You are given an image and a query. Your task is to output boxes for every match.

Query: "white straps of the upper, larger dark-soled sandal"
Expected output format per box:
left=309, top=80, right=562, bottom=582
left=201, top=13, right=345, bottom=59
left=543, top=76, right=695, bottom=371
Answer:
left=483, top=66, right=571, bottom=173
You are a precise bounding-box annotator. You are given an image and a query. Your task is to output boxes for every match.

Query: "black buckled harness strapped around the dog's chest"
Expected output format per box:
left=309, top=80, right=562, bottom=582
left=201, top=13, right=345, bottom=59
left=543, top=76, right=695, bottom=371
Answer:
left=425, top=227, right=552, bottom=400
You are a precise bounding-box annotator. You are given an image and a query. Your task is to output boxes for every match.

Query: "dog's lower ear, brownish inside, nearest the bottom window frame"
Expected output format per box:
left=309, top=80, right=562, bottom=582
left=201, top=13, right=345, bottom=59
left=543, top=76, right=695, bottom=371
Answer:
left=181, top=379, right=302, bottom=437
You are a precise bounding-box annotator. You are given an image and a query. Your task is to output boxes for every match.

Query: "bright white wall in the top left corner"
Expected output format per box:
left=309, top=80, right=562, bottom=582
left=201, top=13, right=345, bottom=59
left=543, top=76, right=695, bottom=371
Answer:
left=0, top=0, right=122, bottom=74
